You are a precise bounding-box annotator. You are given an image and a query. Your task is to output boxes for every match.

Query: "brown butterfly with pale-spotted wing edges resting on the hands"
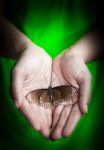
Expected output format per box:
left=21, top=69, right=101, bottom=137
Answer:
left=26, top=85, right=78, bottom=108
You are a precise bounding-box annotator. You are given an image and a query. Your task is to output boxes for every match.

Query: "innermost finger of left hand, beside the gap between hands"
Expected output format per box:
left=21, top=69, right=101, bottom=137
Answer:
left=38, top=106, right=49, bottom=138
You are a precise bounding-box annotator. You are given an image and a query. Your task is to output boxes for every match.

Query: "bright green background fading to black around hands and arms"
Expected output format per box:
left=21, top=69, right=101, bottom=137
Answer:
left=0, top=0, right=104, bottom=150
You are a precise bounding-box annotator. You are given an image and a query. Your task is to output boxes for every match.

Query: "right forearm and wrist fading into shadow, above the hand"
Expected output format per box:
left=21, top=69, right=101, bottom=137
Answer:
left=62, top=30, right=104, bottom=63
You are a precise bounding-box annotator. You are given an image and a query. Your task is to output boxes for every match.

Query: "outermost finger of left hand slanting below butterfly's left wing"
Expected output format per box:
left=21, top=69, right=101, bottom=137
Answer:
left=19, top=100, right=40, bottom=131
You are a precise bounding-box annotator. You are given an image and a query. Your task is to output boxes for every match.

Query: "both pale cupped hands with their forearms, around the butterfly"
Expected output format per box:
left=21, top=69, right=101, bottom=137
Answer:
left=0, top=19, right=103, bottom=140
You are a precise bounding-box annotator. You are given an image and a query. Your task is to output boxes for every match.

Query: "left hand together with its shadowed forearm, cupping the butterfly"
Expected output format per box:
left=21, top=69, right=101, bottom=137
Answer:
left=0, top=18, right=52, bottom=137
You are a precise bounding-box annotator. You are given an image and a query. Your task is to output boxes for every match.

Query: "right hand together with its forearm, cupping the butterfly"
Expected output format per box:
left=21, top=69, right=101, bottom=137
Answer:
left=51, top=31, right=104, bottom=140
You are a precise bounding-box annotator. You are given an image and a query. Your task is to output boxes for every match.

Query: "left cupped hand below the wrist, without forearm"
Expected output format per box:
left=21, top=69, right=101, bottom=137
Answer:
left=11, top=42, right=52, bottom=138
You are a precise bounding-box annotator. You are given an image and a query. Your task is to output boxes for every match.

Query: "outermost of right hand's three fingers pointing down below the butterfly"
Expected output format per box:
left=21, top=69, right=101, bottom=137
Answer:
left=62, top=104, right=81, bottom=137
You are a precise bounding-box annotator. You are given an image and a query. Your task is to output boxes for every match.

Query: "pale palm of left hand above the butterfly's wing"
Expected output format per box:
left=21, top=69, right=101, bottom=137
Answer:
left=21, top=49, right=52, bottom=96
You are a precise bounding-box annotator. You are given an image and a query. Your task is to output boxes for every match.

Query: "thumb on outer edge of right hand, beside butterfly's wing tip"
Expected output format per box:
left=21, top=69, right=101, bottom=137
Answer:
left=79, top=74, right=91, bottom=113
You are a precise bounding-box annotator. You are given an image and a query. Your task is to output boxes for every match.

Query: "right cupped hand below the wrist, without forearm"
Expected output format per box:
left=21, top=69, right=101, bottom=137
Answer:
left=51, top=50, right=91, bottom=140
